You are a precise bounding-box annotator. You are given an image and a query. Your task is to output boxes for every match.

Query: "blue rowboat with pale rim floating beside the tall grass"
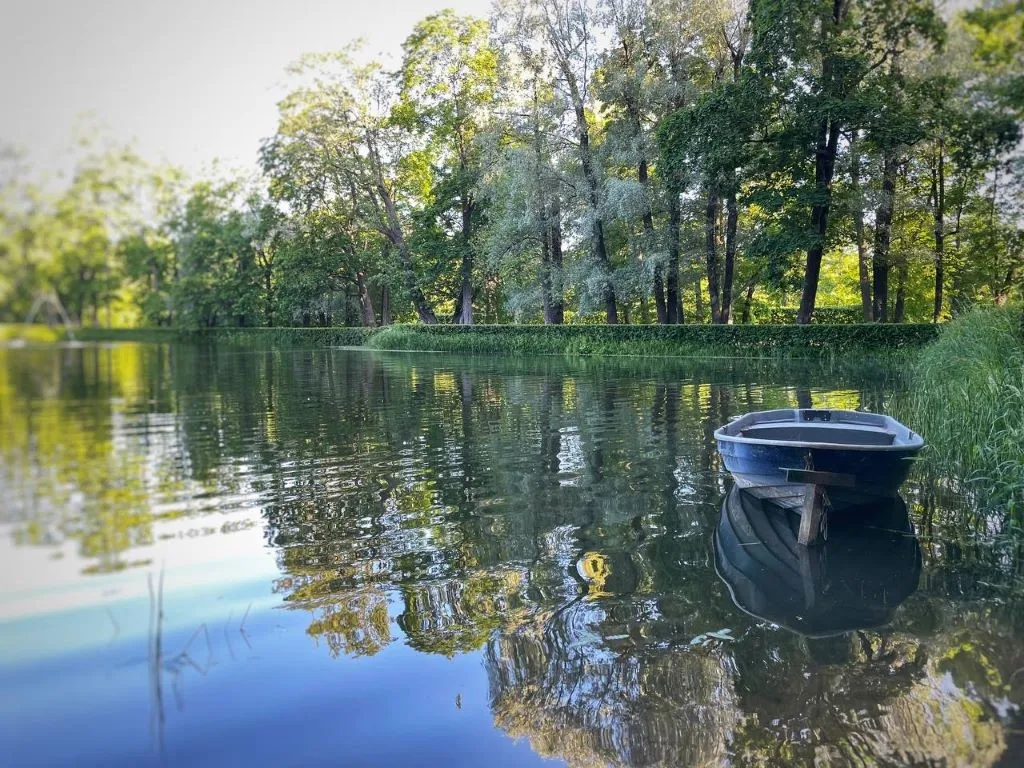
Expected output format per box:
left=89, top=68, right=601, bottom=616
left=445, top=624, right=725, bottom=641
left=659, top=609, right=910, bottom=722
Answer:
left=715, top=409, right=925, bottom=496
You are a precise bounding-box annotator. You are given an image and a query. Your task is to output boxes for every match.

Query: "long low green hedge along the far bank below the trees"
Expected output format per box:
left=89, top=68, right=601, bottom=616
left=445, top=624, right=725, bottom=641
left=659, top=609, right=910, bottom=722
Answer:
left=0, top=324, right=939, bottom=357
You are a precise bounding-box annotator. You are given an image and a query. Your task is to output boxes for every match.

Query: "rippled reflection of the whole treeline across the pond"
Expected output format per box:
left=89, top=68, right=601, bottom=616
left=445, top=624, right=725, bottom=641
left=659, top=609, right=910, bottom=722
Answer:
left=8, top=347, right=1024, bottom=765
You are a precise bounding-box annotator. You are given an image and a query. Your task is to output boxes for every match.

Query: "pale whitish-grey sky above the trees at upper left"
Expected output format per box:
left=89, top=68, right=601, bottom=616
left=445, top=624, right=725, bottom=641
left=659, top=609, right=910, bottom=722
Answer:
left=0, top=0, right=490, bottom=182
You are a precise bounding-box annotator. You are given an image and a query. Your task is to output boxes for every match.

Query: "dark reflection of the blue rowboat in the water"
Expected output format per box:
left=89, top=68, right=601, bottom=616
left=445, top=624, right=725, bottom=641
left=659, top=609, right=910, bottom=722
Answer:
left=715, top=485, right=921, bottom=649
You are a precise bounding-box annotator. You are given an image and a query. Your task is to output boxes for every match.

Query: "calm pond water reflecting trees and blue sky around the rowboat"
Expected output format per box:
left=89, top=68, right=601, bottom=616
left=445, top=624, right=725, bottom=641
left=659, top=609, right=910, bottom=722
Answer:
left=0, top=344, right=1024, bottom=766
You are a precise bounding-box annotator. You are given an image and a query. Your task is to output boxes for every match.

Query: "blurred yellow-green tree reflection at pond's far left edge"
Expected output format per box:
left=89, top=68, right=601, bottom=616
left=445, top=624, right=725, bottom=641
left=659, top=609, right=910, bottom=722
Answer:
left=0, top=347, right=184, bottom=572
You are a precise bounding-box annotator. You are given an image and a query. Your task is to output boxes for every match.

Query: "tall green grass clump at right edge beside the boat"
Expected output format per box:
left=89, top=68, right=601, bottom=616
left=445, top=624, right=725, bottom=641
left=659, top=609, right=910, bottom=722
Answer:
left=911, top=307, right=1024, bottom=523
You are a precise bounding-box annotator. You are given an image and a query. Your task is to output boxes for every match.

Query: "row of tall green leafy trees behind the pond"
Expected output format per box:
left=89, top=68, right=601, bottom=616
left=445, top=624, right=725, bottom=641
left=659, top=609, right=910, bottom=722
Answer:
left=0, top=0, right=1024, bottom=328
